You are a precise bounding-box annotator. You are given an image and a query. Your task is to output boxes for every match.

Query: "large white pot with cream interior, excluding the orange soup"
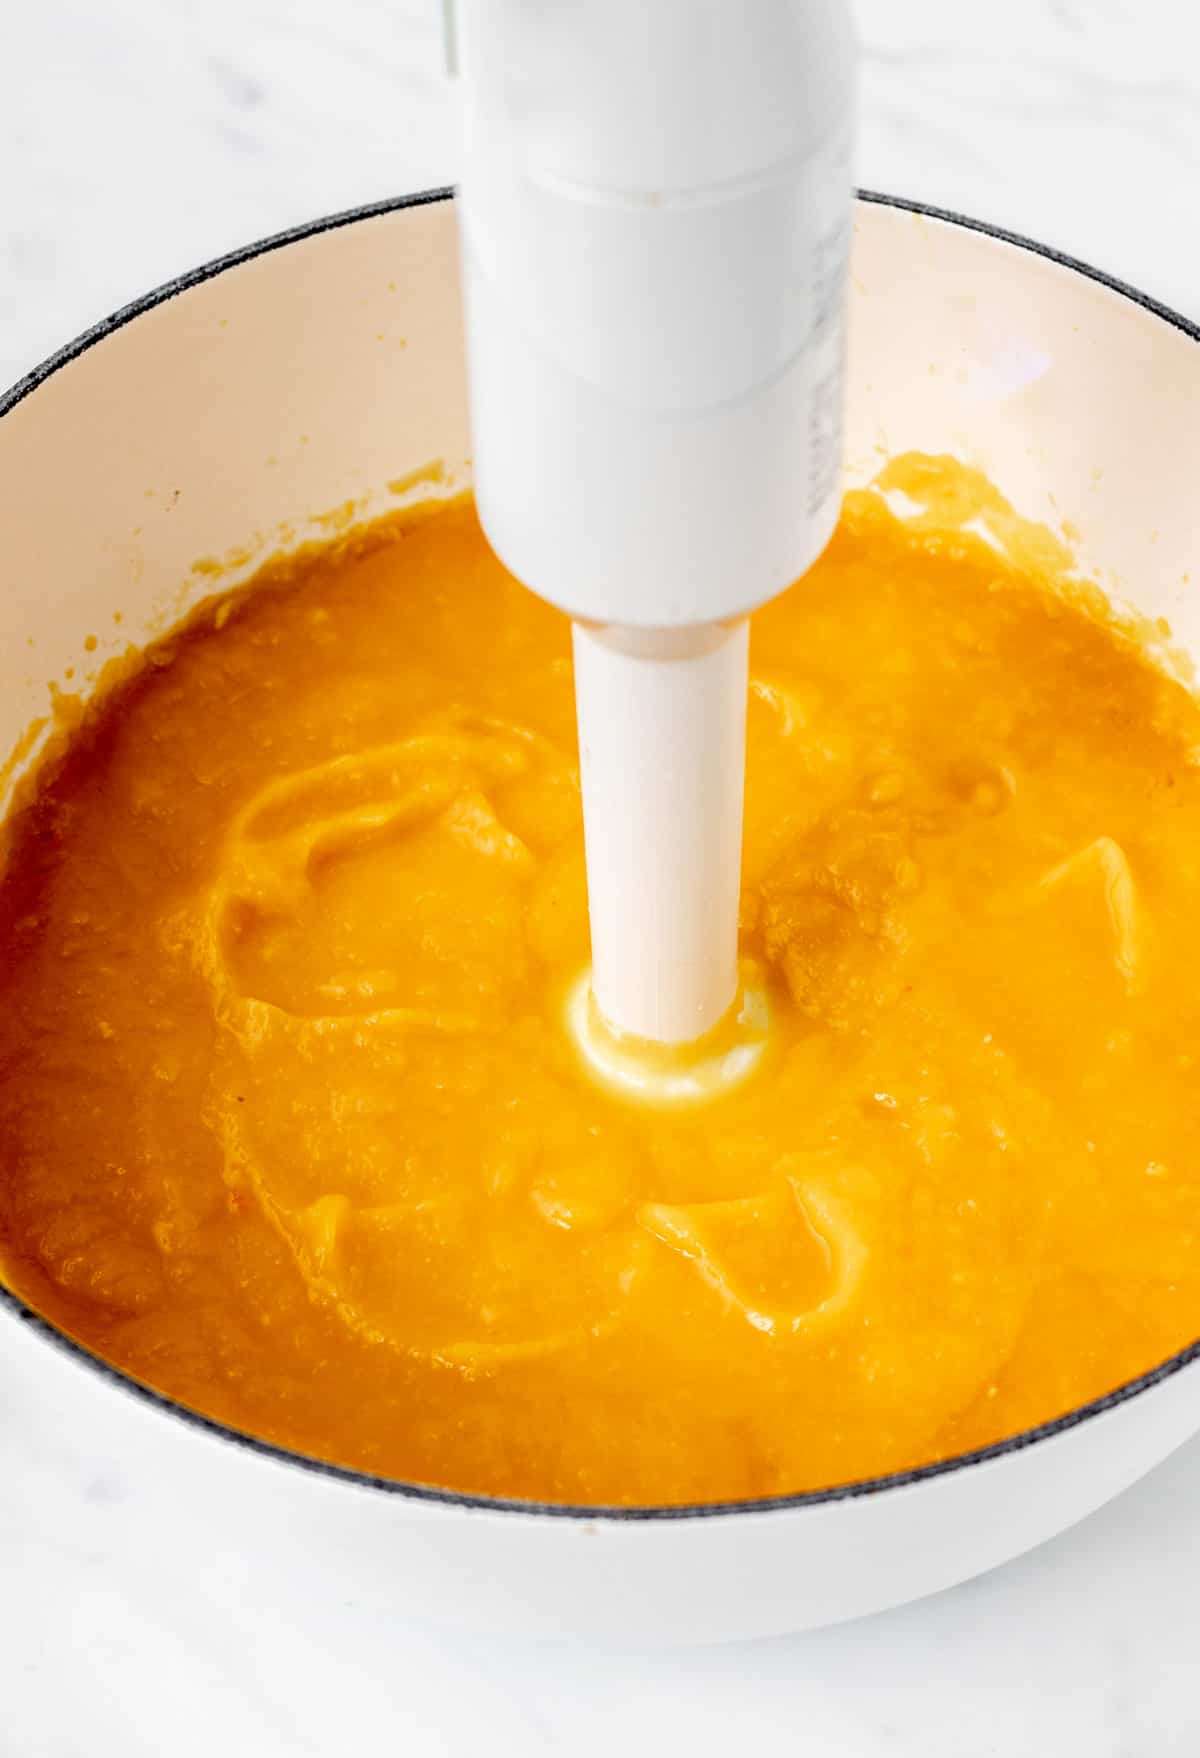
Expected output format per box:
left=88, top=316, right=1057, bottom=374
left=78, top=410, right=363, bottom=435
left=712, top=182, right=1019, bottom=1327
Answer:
left=0, top=195, right=1200, bottom=1642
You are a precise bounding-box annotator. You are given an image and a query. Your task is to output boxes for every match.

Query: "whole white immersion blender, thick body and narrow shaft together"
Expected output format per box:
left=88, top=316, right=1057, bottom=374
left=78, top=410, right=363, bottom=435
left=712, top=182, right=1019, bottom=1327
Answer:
left=453, top=0, right=854, bottom=1042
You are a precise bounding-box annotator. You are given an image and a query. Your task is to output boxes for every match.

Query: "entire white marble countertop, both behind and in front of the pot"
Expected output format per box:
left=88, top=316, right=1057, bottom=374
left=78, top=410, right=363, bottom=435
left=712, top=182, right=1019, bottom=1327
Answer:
left=0, top=0, right=1200, bottom=1758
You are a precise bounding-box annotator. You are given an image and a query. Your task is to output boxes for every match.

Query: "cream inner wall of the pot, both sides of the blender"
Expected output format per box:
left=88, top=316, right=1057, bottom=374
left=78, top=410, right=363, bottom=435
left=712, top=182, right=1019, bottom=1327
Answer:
left=0, top=202, right=1200, bottom=805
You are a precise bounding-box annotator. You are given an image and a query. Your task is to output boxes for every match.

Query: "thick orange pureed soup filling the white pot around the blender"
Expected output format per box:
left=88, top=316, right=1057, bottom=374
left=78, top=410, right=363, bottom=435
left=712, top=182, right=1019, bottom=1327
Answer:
left=0, top=459, right=1200, bottom=1503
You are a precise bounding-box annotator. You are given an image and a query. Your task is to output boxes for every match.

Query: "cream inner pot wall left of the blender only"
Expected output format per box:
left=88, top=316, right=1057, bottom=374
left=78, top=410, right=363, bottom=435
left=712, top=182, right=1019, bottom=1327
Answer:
left=0, top=202, right=469, bottom=807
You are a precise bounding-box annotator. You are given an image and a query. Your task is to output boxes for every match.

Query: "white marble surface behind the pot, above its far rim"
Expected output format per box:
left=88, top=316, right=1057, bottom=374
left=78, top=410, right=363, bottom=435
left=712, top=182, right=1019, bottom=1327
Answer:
left=0, top=0, right=1200, bottom=383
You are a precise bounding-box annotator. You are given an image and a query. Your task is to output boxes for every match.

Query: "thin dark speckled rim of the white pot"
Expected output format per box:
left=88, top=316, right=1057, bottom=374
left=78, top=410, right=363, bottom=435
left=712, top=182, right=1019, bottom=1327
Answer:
left=0, top=190, right=1200, bottom=1522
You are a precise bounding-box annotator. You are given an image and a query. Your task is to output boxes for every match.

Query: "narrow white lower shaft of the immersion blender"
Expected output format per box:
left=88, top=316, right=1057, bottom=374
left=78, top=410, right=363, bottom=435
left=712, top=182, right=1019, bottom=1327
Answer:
left=575, top=619, right=748, bottom=1044
